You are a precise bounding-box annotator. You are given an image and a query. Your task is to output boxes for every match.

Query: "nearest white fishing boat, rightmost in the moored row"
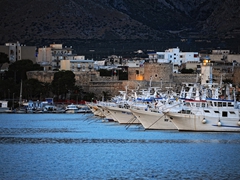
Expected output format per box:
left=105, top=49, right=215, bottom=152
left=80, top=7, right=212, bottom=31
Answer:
left=166, top=99, right=240, bottom=132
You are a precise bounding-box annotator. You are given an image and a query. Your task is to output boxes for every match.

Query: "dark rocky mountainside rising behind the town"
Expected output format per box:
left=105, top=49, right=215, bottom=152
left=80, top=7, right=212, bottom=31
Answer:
left=0, top=0, right=240, bottom=53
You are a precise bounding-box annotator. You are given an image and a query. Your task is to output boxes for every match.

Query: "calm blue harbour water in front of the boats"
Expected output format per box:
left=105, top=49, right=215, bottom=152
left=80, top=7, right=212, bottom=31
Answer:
left=0, top=114, right=240, bottom=180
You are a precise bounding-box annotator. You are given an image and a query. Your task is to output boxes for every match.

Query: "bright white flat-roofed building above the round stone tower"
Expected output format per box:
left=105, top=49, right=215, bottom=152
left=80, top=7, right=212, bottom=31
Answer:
left=149, top=47, right=200, bottom=73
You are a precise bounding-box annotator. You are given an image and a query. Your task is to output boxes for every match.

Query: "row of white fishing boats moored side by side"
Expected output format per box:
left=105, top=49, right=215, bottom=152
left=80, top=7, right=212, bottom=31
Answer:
left=87, top=83, right=240, bottom=132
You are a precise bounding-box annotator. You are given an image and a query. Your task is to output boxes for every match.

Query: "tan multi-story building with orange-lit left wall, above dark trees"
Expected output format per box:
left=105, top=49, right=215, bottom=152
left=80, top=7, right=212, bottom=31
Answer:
left=37, top=44, right=74, bottom=70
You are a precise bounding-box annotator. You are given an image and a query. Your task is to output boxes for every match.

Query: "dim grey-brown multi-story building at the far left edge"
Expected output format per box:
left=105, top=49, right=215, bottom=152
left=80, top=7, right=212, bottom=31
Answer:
left=0, top=41, right=36, bottom=69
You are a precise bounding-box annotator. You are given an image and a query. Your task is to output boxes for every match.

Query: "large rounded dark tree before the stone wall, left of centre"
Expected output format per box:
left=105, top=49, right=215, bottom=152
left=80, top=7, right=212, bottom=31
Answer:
left=51, top=71, right=76, bottom=100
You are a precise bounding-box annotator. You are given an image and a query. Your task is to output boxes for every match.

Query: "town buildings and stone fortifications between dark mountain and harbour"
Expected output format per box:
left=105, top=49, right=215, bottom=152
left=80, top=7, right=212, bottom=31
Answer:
left=0, top=42, right=240, bottom=97
